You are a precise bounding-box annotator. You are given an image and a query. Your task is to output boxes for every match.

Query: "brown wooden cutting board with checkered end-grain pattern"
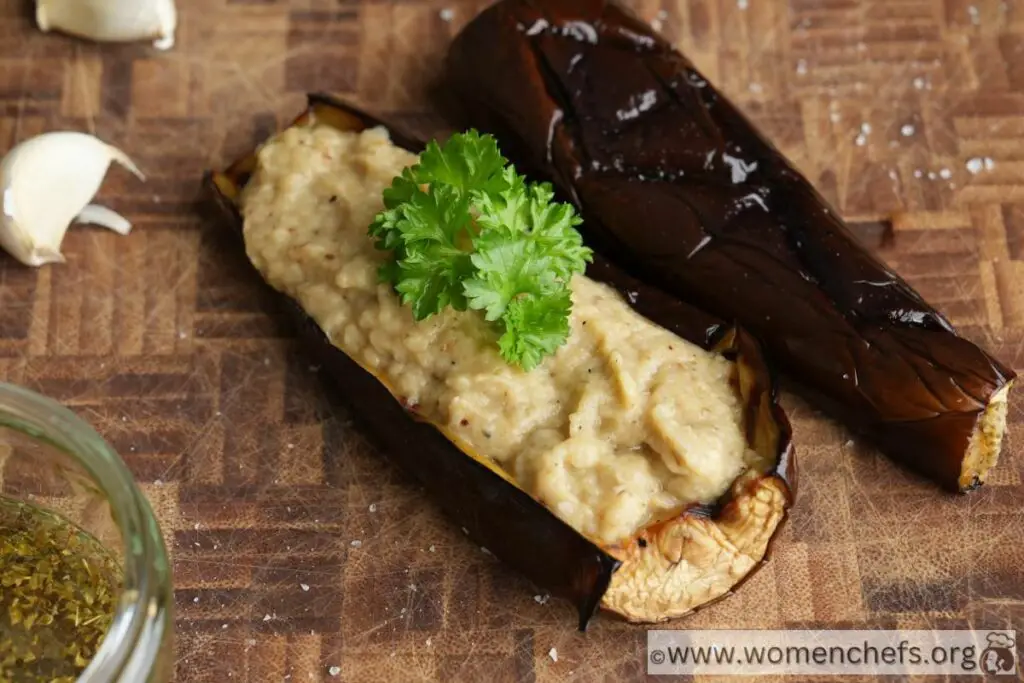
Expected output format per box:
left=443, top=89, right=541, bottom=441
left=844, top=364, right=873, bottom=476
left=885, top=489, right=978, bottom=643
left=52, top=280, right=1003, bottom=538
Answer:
left=0, top=0, right=1024, bottom=683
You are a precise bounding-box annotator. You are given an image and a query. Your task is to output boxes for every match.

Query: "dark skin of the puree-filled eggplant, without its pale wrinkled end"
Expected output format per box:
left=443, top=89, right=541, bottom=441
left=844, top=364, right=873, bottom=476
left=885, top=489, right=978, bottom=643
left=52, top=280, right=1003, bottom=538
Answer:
left=204, top=94, right=797, bottom=631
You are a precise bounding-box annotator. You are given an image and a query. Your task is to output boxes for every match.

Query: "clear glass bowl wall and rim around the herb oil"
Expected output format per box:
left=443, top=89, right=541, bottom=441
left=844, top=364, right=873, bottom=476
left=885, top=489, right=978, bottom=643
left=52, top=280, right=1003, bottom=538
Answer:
left=0, top=383, right=173, bottom=683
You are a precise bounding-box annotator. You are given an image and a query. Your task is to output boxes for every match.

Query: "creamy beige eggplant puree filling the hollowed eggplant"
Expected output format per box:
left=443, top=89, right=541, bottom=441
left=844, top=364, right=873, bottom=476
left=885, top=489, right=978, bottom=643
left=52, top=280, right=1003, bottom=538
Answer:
left=242, top=126, right=758, bottom=545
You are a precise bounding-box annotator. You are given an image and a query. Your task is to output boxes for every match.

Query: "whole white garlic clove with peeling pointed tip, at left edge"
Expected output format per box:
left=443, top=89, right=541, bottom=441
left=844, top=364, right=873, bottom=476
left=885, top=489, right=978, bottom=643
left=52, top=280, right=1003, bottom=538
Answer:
left=0, top=131, right=145, bottom=266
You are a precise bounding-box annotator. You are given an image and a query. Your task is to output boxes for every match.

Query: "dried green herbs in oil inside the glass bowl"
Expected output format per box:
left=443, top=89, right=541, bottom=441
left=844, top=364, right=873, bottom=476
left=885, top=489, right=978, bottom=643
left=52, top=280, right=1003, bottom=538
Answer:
left=0, top=497, right=122, bottom=683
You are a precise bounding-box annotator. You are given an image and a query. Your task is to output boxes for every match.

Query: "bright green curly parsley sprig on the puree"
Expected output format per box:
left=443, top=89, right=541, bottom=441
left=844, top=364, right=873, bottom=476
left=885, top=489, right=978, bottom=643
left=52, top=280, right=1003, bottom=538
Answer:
left=370, top=130, right=591, bottom=370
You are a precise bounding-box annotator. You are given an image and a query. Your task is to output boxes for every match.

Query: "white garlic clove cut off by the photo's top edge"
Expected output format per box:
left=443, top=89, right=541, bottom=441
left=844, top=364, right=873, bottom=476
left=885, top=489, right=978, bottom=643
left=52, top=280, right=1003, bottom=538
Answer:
left=36, top=0, right=178, bottom=50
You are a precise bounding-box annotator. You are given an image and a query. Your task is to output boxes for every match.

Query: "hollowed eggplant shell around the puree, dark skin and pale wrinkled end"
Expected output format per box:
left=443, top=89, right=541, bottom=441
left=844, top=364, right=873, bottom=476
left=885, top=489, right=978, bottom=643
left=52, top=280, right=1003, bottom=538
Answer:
left=205, top=95, right=796, bottom=630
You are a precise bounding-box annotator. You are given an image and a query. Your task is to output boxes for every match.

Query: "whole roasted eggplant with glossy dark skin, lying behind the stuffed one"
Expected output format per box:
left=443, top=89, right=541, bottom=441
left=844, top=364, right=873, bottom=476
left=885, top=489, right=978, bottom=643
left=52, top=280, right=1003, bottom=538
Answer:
left=445, top=0, right=1015, bottom=490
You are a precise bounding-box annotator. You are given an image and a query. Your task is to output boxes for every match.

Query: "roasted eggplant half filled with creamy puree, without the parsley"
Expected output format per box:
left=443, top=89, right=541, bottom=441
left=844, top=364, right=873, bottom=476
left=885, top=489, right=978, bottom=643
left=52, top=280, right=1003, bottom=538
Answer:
left=207, top=96, right=795, bottom=629
